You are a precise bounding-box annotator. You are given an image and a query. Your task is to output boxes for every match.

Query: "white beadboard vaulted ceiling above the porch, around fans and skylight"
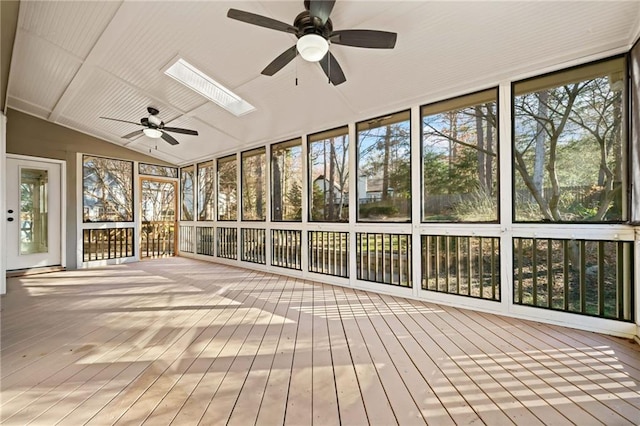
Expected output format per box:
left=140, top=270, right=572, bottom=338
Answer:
left=7, top=0, right=640, bottom=164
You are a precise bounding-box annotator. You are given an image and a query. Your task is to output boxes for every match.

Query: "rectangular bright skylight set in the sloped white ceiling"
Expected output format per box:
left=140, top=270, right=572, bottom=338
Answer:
left=164, top=58, right=256, bottom=117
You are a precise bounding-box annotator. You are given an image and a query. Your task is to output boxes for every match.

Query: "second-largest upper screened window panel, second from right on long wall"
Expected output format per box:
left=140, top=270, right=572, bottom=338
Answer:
left=422, top=89, right=499, bottom=222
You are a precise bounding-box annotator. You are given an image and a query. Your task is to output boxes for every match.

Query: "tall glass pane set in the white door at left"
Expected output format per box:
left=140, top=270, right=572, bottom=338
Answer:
left=20, top=168, right=49, bottom=254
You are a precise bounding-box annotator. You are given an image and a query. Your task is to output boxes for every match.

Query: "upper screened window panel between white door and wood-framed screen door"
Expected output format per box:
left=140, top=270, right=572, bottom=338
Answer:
left=82, top=155, right=133, bottom=222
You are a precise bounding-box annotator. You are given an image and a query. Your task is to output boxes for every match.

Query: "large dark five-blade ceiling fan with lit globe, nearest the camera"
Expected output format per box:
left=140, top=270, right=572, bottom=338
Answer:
left=227, top=0, right=397, bottom=86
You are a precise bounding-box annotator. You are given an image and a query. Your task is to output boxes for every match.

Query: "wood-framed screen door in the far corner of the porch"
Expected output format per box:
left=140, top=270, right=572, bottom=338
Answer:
left=140, top=178, right=178, bottom=259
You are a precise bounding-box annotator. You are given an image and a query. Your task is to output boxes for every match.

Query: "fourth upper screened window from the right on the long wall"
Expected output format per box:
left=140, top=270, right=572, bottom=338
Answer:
left=309, top=127, right=349, bottom=222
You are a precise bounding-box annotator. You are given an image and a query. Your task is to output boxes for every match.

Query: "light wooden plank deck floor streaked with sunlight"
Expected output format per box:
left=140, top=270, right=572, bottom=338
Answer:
left=1, top=258, right=640, bottom=426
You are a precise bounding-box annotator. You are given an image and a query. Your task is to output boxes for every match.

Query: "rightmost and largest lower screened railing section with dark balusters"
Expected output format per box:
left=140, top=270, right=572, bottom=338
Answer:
left=513, top=238, right=634, bottom=321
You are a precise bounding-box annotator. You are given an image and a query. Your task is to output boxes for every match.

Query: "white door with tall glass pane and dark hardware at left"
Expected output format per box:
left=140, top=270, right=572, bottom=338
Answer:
left=4, top=156, right=62, bottom=270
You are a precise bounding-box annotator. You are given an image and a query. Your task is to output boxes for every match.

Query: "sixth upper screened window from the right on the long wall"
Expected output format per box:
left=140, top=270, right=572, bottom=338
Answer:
left=242, top=148, right=267, bottom=220
